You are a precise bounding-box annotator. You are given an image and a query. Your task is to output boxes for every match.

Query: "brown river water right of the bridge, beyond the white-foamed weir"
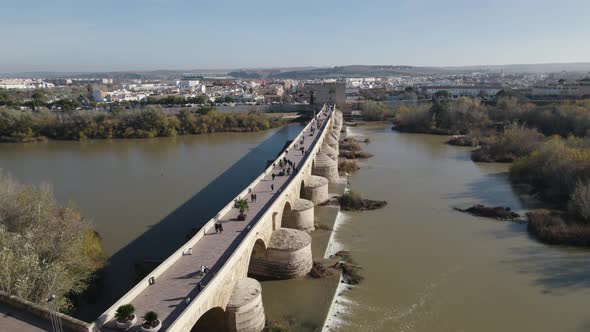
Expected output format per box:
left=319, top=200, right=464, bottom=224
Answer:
left=335, top=125, right=590, bottom=331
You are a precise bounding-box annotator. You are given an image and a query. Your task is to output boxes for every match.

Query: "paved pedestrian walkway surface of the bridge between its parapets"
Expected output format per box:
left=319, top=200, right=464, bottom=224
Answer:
left=120, top=108, right=330, bottom=331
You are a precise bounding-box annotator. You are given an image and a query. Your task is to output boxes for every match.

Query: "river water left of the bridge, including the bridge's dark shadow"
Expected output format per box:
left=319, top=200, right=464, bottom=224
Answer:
left=0, top=125, right=301, bottom=321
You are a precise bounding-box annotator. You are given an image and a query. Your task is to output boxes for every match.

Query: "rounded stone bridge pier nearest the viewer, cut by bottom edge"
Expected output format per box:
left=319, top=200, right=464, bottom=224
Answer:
left=225, top=278, right=265, bottom=332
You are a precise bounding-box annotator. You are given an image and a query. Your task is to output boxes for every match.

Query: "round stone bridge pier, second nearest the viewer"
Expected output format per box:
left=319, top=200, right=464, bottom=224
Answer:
left=248, top=228, right=313, bottom=279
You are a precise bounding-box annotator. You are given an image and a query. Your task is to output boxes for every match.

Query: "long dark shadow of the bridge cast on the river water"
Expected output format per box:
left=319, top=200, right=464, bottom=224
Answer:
left=75, top=124, right=303, bottom=322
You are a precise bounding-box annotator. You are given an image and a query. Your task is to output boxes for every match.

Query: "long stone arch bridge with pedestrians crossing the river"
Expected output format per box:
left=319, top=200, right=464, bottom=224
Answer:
left=91, top=106, right=342, bottom=332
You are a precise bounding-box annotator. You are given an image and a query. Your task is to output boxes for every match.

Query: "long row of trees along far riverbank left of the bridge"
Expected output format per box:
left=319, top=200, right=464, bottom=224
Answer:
left=0, top=106, right=283, bottom=142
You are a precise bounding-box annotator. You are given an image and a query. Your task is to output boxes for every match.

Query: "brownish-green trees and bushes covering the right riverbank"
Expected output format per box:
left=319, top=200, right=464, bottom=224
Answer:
left=394, top=94, right=590, bottom=245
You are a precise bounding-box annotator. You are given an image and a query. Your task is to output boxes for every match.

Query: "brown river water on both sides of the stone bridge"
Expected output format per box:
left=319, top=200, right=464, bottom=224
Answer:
left=0, top=125, right=590, bottom=332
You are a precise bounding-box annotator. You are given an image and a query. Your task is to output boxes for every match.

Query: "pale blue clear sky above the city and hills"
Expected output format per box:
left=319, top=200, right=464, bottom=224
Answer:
left=0, top=0, right=590, bottom=72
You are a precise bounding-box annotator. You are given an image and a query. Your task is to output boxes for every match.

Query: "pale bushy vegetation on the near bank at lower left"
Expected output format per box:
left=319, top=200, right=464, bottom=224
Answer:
left=0, top=174, right=103, bottom=312
